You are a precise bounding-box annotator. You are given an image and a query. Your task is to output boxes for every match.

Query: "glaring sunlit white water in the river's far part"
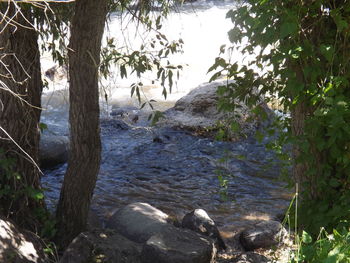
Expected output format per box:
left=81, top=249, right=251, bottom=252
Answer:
left=42, top=1, right=235, bottom=119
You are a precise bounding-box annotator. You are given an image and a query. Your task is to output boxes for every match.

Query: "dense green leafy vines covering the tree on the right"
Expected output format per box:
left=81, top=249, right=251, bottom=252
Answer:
left=210, top=0, right=350, bottom=235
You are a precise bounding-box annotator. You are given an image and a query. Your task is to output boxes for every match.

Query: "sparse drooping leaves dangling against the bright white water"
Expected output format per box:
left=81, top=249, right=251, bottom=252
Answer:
left=99, top=15, right=184, bottom=125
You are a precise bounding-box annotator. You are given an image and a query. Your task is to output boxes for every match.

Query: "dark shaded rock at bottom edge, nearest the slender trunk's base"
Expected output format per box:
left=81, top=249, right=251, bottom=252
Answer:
left=60, top=229, right=142, bottom=263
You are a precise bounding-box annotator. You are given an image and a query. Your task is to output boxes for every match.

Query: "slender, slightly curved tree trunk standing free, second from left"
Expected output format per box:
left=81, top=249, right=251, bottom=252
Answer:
left=57, top=0, right=107, bottom=250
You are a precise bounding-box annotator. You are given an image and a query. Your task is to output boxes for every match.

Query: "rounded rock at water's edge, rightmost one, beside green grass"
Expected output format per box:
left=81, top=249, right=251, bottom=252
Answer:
left=239, top=221, right=289, bottom=251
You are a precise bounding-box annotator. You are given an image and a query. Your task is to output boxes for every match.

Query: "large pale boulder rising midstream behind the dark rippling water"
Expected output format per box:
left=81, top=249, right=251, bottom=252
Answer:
left=158, top=81, right=272, bottom=138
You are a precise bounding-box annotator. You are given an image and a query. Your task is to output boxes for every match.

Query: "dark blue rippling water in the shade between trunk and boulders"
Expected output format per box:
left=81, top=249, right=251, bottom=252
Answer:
left=43, top=119, right=289, bottom=233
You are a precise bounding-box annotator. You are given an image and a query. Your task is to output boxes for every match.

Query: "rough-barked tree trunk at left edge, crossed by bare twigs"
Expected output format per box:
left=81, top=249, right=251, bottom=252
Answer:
left=0, top=3, right=44, bottom=228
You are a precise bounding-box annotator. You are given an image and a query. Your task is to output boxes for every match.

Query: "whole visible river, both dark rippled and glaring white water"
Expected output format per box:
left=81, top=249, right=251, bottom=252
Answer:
left=42, top=2, right=290, bottom=235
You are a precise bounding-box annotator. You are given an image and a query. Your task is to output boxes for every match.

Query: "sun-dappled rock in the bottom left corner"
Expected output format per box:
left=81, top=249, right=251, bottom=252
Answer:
left=0, top=217, right=47, bottom=263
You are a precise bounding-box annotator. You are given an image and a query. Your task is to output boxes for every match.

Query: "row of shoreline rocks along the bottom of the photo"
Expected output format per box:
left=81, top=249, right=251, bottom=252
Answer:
left=0, top=203, right=290, bottom=263
